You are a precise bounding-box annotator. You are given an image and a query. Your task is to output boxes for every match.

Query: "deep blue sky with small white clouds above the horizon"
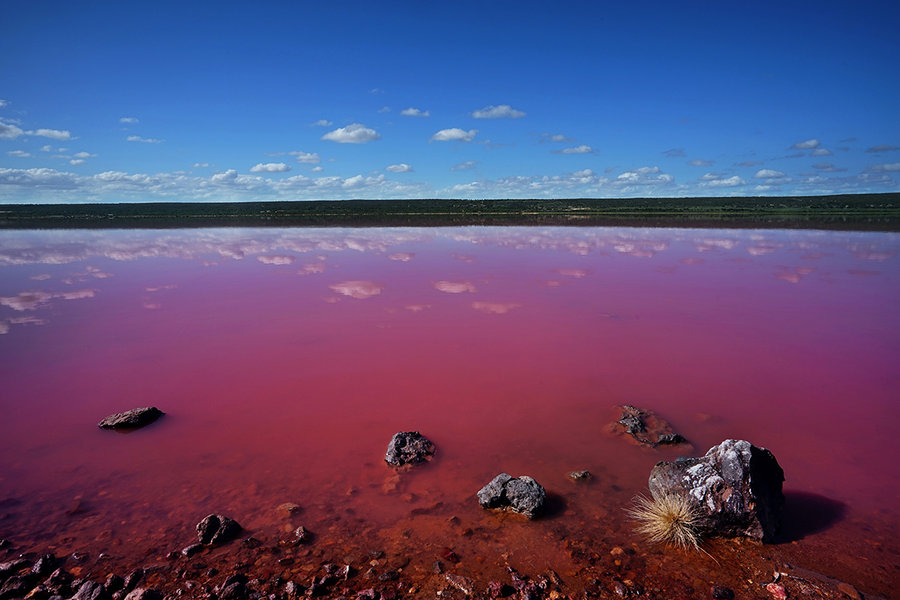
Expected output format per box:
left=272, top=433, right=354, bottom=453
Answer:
left=0, top=0, right=900, bottom=203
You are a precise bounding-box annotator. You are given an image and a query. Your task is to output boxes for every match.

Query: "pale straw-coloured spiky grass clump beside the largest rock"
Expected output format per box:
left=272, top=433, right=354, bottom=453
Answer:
left=628, top=494, right=701, bottom=550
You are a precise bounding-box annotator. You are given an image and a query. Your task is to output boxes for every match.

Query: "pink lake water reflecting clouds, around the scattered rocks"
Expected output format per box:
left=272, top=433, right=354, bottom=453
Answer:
left=0, top=227, right=900, bottom=593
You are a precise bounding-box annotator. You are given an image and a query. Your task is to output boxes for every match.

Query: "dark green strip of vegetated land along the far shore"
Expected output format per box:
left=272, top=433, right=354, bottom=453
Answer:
left=0, top=193, right=900, bottom=231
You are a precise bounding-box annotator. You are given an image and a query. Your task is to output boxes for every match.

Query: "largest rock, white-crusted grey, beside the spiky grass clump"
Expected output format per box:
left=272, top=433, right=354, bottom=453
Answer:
left=649, top=440, right=784, bottom=542
